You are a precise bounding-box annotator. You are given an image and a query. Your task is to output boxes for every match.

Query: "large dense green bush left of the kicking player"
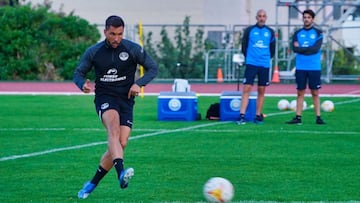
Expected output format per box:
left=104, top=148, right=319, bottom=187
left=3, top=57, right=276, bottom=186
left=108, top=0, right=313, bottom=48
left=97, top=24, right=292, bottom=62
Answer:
left=0, top=4, right=100, bottom=80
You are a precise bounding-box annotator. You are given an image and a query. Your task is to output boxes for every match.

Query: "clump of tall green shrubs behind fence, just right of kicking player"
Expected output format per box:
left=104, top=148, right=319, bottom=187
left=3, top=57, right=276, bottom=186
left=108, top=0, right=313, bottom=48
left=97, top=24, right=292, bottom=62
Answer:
left=144, top=16, right=206, bottom=78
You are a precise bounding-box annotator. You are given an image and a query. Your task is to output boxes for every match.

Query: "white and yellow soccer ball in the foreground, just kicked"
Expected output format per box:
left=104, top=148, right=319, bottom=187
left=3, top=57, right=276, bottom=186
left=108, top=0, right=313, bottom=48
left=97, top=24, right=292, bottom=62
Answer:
left=203, top=177, right=234, bottom=203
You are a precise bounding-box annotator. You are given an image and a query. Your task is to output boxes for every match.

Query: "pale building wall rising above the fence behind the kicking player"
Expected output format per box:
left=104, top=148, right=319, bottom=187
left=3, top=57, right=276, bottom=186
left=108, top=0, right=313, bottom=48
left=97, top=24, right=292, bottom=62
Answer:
left=26, top=0, right=276, bottom=25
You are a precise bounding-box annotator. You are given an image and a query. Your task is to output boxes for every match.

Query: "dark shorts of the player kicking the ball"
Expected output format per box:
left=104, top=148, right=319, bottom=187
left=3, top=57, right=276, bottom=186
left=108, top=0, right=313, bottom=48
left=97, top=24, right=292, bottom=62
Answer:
left=94, top=95, right=135, bottom=128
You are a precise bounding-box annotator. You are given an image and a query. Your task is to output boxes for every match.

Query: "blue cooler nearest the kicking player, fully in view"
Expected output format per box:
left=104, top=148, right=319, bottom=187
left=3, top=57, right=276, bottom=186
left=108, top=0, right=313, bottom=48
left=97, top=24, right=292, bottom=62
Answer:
left=158, top=92, right=198, bottom=121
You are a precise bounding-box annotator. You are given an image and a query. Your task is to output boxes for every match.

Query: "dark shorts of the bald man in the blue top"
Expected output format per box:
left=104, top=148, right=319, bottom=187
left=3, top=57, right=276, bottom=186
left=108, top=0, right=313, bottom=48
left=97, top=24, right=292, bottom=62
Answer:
left=243, top=64, right=270, bottom=86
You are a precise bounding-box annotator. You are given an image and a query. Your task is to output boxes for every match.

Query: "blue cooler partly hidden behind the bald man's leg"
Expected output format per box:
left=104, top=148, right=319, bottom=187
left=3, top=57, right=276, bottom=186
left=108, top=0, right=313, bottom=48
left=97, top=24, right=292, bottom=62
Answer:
left=220, top=91, right=257, bottom=121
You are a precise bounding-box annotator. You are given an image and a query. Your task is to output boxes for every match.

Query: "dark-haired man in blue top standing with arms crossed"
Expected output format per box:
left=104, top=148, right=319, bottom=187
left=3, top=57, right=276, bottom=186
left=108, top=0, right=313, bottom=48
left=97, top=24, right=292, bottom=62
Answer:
left=286, top=9, right=325, bottom=125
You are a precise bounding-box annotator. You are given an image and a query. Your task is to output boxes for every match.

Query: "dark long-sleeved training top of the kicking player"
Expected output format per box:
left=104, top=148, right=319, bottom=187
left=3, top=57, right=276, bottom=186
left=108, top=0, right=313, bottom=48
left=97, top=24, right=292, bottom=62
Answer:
left=74, top=39, right=158, bottom=97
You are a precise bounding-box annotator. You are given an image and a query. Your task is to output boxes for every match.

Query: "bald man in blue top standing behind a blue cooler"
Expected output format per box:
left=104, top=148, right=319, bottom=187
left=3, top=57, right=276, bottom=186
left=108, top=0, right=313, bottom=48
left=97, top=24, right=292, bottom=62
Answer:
left=236, top=9, right=276, bottom=125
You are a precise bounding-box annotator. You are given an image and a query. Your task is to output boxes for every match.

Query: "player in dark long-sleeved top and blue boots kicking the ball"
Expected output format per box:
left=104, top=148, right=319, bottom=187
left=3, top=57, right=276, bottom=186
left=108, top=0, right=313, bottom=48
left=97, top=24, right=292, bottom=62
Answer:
left=74, top=16, right=158, bottom=199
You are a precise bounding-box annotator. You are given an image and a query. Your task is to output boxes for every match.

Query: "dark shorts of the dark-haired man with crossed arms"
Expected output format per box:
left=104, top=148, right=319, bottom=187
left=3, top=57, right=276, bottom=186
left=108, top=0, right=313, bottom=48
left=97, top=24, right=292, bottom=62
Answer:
left=295, top=70, right=321, bottom=90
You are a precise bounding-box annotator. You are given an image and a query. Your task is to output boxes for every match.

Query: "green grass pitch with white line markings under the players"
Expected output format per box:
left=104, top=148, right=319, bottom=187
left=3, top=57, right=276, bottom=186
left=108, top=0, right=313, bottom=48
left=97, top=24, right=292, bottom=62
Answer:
left=0, top=95, right=360, bottom=202
